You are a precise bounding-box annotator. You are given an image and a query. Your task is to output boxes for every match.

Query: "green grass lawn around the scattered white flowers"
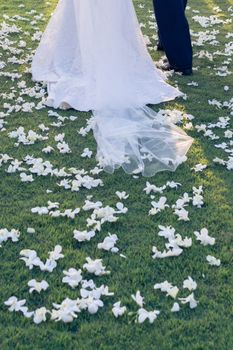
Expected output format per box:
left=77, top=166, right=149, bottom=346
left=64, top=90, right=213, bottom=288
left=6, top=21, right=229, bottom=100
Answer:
left=0, top=0, right=233, bottom=350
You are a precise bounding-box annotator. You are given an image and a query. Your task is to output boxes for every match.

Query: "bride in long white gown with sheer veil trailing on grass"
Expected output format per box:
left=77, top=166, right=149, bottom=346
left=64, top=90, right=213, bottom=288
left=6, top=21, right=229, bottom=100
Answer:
left=32, top=0, right=193, bottom=176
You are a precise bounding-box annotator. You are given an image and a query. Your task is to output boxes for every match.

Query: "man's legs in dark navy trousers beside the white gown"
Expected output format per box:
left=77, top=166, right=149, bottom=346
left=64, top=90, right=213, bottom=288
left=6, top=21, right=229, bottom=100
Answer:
left=153, top=0, right=192, bottom=75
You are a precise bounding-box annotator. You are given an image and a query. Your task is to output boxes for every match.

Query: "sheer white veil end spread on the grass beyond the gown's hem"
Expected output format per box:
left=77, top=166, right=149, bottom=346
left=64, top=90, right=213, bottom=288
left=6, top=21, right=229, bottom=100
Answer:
left=94, top=107, right=192, bottom=176
